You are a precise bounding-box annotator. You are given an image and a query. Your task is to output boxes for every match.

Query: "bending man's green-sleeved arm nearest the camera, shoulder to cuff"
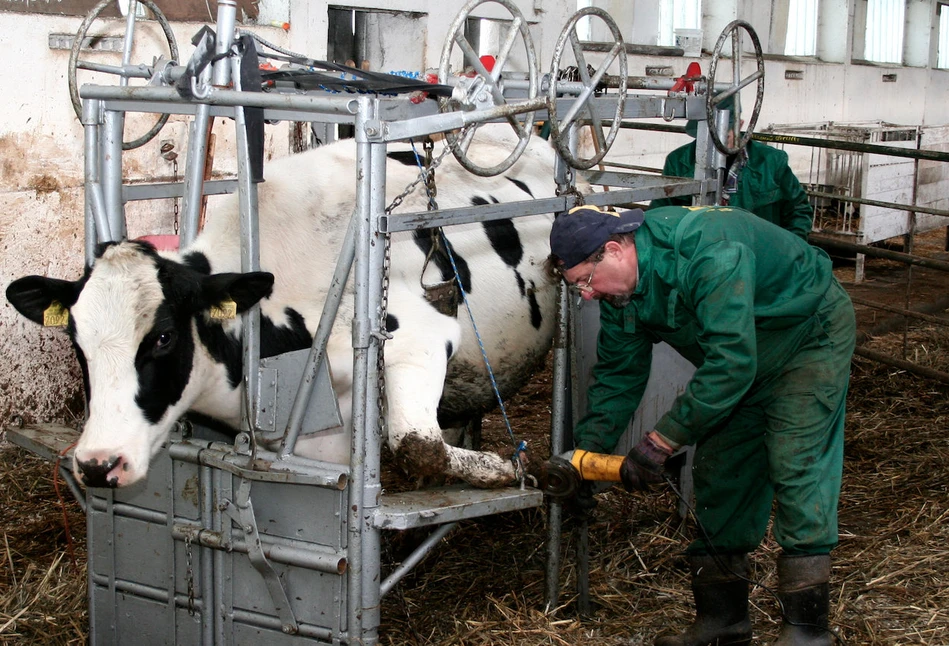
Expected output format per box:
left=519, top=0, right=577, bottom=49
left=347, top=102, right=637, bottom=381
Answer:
left=655, top=241, right=757, bottom=445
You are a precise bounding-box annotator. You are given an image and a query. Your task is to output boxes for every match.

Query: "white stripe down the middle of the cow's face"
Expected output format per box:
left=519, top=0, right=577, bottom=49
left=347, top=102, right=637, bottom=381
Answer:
left=71, top=245, right=165, bottom=485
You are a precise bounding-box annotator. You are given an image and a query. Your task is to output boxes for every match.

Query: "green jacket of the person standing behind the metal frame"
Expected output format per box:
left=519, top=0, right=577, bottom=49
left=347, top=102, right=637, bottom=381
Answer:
left=650, top=141, right=814, bottom=240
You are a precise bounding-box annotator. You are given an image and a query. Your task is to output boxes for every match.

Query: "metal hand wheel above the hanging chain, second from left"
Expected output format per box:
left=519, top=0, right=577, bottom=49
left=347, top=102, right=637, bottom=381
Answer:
left=438, top=0, right=540, bottom=177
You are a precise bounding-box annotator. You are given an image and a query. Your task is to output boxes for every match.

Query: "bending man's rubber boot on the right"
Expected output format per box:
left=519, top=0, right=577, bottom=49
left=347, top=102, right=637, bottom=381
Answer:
left=774, top=554, right=834, bottom=646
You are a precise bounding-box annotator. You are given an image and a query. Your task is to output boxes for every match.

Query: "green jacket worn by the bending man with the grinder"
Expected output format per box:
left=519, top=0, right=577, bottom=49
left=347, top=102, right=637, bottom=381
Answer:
left=574, top=207, right=835, bottom=453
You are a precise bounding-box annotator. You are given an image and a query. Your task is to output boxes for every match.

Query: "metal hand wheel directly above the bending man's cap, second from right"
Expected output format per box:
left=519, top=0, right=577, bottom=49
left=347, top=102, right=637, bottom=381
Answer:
left=547, top=7, right=628, bottom=169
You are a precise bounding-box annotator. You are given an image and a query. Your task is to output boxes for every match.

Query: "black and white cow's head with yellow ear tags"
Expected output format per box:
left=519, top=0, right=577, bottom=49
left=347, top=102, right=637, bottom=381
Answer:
left=7, top=242, right=273, bottom=487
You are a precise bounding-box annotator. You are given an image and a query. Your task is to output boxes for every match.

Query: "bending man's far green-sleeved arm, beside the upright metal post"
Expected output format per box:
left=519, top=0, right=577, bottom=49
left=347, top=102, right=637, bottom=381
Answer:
left=573, top=303, right=652, bottom=453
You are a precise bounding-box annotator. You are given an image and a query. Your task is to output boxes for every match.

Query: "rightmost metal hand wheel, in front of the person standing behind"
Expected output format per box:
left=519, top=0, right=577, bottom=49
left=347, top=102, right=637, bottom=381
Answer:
left=705, top=20, right=764, bottom=155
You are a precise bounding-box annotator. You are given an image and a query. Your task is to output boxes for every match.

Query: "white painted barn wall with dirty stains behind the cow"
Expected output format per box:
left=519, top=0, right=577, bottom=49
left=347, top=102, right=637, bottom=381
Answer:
left=0, top=0, right=949, bottom=428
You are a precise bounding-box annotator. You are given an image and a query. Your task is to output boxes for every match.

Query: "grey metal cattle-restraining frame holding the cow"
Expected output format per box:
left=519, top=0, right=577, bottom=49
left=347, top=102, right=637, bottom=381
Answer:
left=5, top=0, right=732, bottom=644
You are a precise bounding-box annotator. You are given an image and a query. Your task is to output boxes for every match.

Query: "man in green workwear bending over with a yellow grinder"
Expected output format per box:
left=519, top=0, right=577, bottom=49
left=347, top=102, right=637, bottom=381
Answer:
left=548, top=206, right=855, bottom=646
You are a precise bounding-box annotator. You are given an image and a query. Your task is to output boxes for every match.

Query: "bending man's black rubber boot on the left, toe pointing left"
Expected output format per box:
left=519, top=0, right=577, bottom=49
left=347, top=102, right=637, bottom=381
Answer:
left=656, top=554, right=751, bottom=646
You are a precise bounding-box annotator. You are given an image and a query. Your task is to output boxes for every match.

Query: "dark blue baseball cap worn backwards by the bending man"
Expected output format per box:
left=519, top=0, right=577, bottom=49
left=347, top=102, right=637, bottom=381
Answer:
left=550, top=206, right=645, bottom=269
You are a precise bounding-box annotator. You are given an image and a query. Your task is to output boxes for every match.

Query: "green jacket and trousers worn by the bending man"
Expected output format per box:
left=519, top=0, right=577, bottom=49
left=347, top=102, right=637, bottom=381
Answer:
left=574, top=207, right=855, bottom=554
